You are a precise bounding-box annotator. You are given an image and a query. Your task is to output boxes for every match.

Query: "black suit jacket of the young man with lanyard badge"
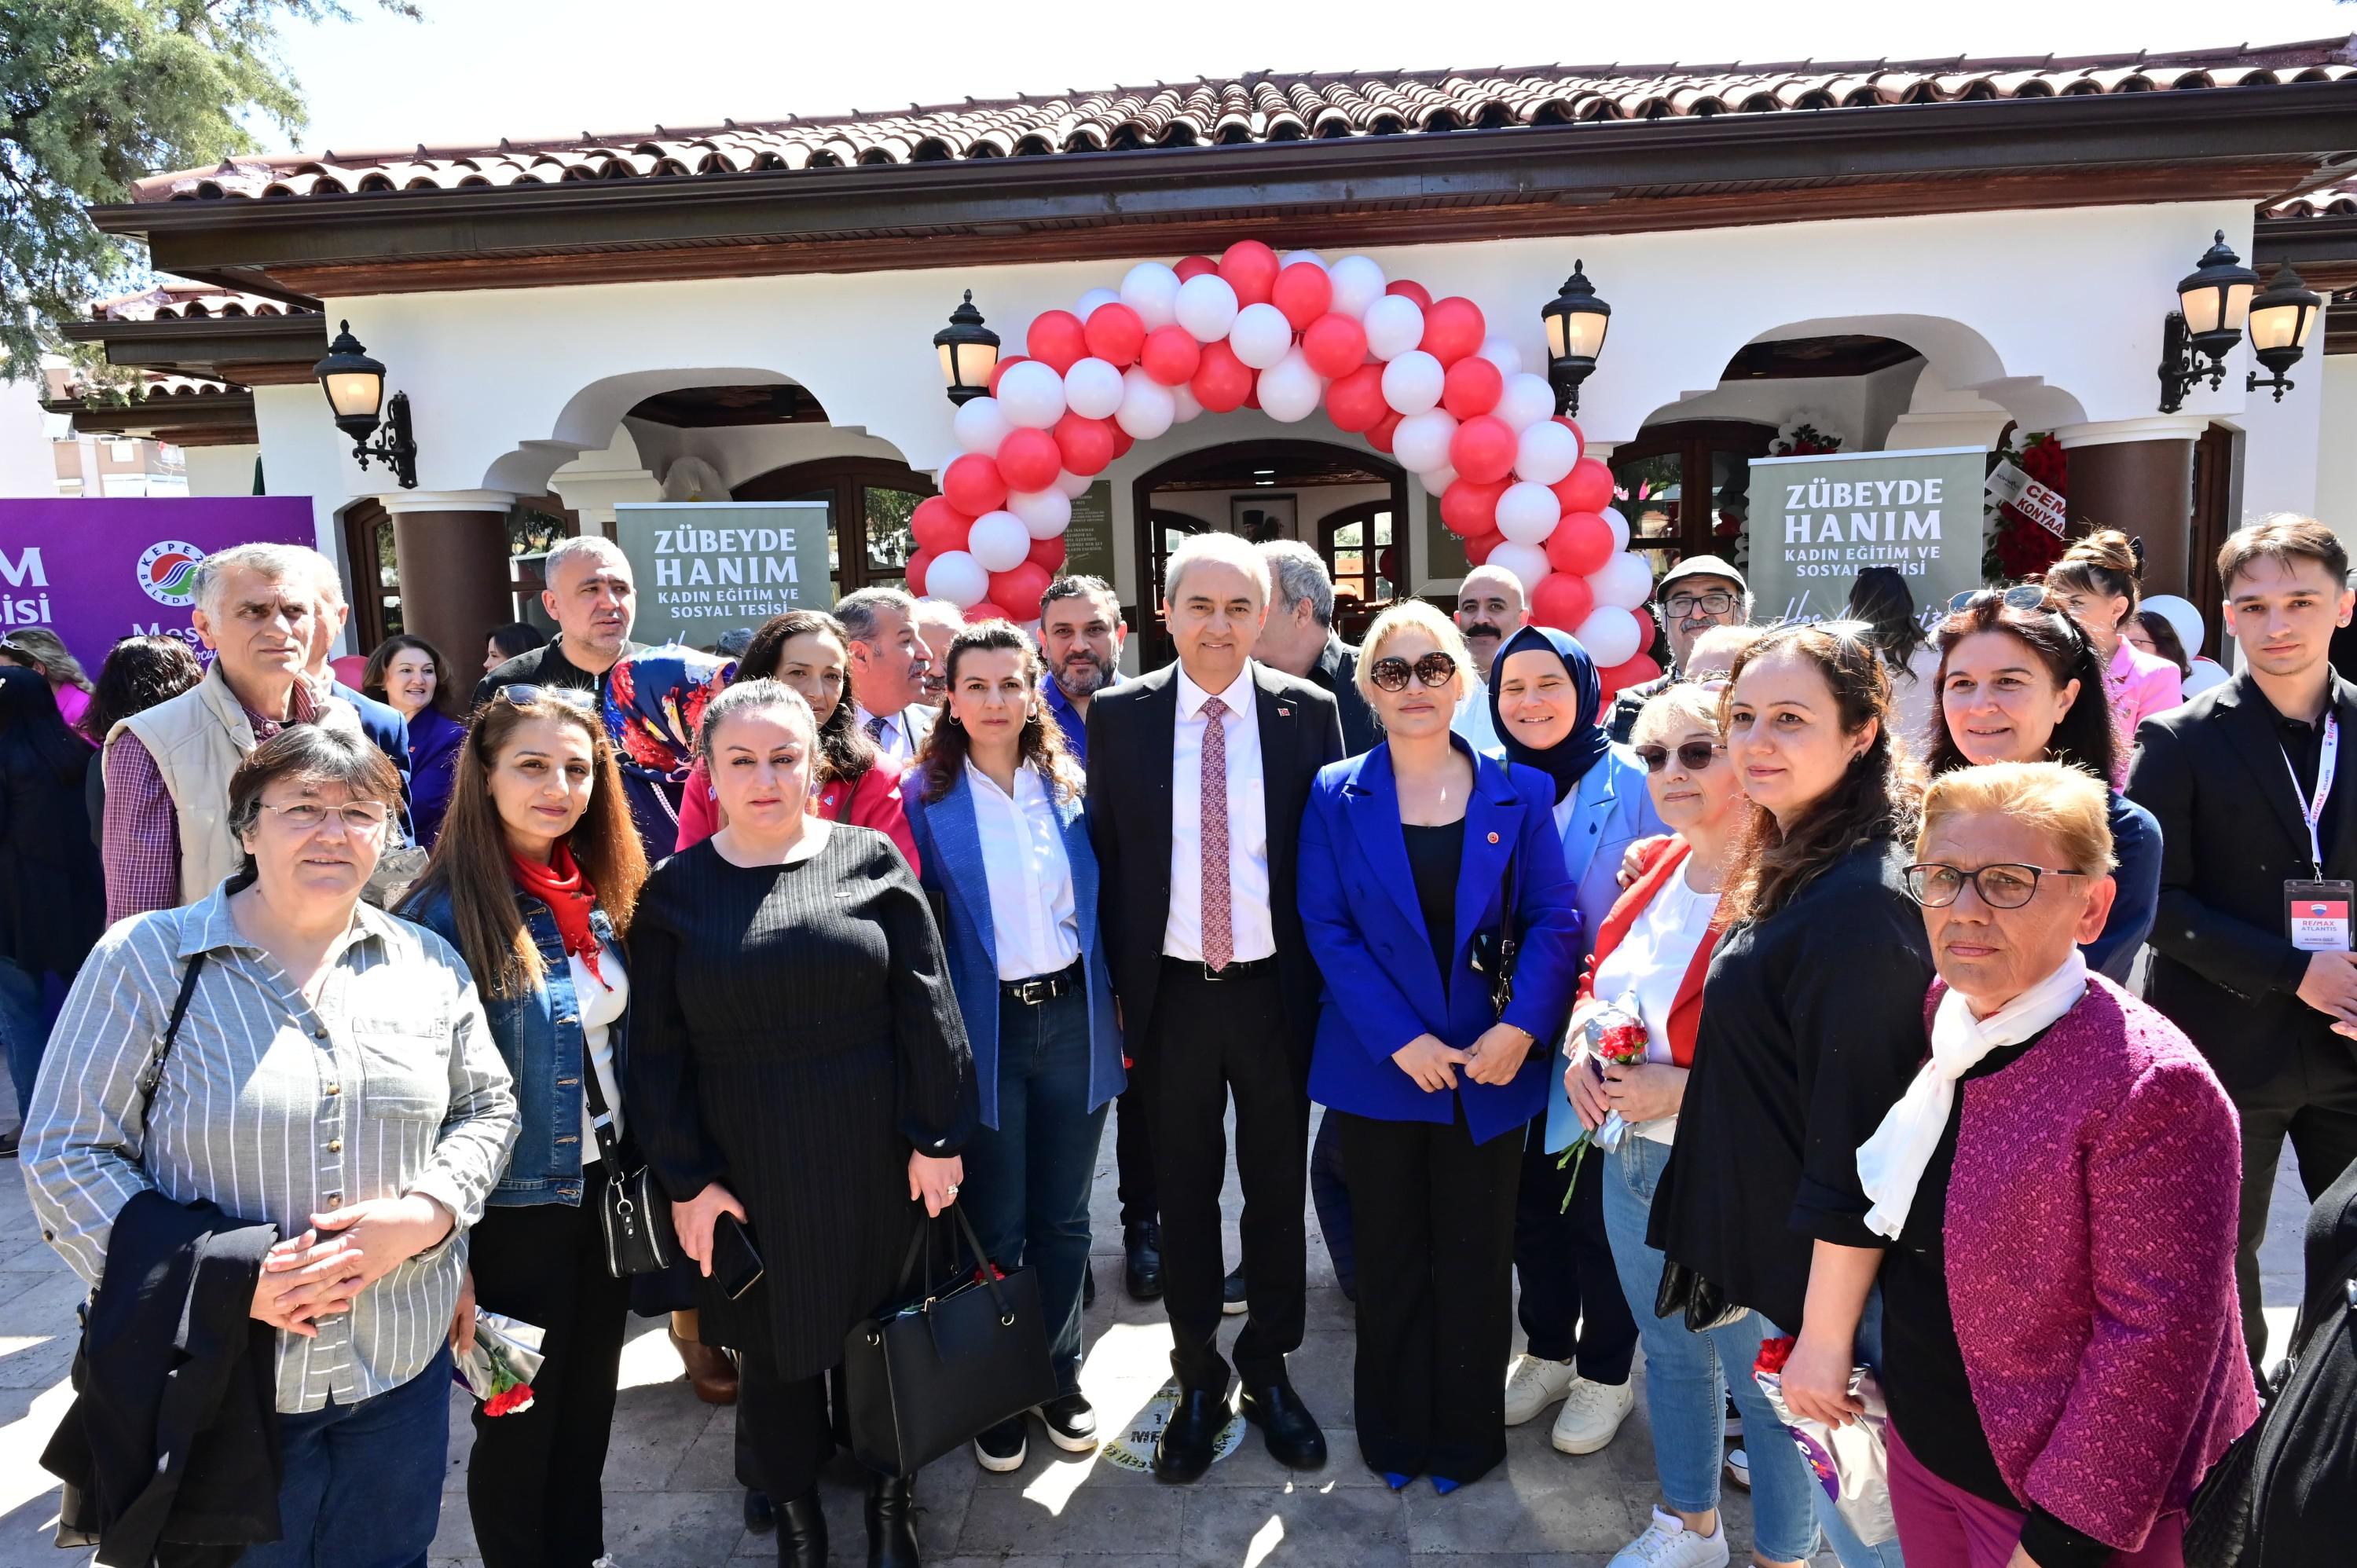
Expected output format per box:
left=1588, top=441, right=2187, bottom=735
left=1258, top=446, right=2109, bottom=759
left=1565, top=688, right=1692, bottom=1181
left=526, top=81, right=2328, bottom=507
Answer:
left=2128, top=672, right=2357, bottom=1094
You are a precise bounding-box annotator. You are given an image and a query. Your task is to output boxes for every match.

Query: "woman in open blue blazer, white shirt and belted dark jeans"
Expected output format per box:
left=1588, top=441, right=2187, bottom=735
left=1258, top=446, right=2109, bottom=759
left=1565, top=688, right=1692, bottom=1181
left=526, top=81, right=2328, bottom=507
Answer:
left=900, top=620, right=1122, bottom=1471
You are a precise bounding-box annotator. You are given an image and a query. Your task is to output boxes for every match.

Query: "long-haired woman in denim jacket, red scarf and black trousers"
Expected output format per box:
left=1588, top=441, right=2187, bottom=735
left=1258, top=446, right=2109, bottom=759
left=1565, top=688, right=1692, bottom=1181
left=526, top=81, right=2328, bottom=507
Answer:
left=401, top=686, right=646, bottom=1568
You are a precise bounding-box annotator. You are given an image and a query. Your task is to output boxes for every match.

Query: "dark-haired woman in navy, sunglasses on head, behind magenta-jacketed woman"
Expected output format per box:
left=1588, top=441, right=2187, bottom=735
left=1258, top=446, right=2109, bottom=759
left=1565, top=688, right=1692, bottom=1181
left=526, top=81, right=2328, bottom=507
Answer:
left=1926, top=584, right=2161, bottom=986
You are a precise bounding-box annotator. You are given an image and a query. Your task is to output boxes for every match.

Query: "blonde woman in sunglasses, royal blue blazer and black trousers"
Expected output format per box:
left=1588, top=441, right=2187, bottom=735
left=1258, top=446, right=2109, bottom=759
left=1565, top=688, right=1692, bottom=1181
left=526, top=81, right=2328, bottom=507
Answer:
left=1299, top=601, right=1579, bottom=1493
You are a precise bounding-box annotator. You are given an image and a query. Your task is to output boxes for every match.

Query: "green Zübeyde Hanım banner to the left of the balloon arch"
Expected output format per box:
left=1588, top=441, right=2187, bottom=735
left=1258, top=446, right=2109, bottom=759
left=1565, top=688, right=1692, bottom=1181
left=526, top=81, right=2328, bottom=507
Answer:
left=613, top=500, right=834, bottom=648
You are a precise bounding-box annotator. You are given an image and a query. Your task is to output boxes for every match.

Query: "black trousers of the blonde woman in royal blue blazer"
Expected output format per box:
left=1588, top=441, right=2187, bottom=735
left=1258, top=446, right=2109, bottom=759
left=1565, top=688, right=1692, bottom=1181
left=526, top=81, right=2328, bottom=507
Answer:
left=1339, top=1097, right=1523, bottom=1481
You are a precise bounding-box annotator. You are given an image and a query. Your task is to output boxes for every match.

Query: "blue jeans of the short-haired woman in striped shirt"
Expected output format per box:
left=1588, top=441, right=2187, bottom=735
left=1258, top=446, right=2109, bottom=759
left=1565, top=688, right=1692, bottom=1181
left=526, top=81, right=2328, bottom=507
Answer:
left=238, top=1325, right=450, bottom=1568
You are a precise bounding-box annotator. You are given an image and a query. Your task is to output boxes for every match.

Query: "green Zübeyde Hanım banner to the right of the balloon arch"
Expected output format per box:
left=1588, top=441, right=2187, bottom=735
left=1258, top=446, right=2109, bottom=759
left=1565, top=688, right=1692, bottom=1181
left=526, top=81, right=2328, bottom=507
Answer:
left=1749, top=445, right=1989, bottom=625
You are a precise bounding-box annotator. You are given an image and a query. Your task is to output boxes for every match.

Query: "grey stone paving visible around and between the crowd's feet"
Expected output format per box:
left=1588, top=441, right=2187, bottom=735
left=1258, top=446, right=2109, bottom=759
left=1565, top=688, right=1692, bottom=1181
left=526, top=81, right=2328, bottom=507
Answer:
left=0, top=1098, right=2305, bottom=1568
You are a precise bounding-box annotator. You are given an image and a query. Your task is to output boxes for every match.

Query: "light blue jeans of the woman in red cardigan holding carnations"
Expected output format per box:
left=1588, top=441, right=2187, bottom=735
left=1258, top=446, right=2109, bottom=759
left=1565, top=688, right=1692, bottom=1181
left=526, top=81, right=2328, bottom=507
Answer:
left=1589, top=1134, right=1820, bottom=1563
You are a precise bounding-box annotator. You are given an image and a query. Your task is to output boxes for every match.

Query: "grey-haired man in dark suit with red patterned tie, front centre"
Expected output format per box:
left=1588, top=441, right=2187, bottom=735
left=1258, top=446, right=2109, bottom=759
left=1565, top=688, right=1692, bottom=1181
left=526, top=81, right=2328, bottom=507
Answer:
left=1089, top=533, right=1341, bottom=1481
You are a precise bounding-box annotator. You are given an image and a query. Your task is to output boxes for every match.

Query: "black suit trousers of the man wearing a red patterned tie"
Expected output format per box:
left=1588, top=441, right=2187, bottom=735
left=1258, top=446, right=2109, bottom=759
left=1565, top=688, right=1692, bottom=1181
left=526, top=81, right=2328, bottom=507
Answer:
left=1148, top=960, right=1310, bottom=1394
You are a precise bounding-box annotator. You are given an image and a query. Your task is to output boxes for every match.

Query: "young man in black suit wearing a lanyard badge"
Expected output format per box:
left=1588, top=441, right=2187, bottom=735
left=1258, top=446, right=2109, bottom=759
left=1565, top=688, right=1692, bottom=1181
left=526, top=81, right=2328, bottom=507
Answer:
left=2128, top=516, right=2357, bottom=1382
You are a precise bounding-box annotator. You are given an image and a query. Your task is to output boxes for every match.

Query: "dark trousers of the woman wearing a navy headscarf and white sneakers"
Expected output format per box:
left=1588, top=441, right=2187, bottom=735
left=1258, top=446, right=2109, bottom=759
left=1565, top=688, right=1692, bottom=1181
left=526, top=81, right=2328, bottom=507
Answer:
left=1501, top=1116, right=1636, bottom=1384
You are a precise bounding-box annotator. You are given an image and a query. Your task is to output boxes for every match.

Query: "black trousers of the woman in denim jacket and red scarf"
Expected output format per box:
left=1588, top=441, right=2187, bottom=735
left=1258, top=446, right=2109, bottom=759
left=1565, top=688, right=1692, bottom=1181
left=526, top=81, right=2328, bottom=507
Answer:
left=467, top=1160, right=629, bottom=1568
